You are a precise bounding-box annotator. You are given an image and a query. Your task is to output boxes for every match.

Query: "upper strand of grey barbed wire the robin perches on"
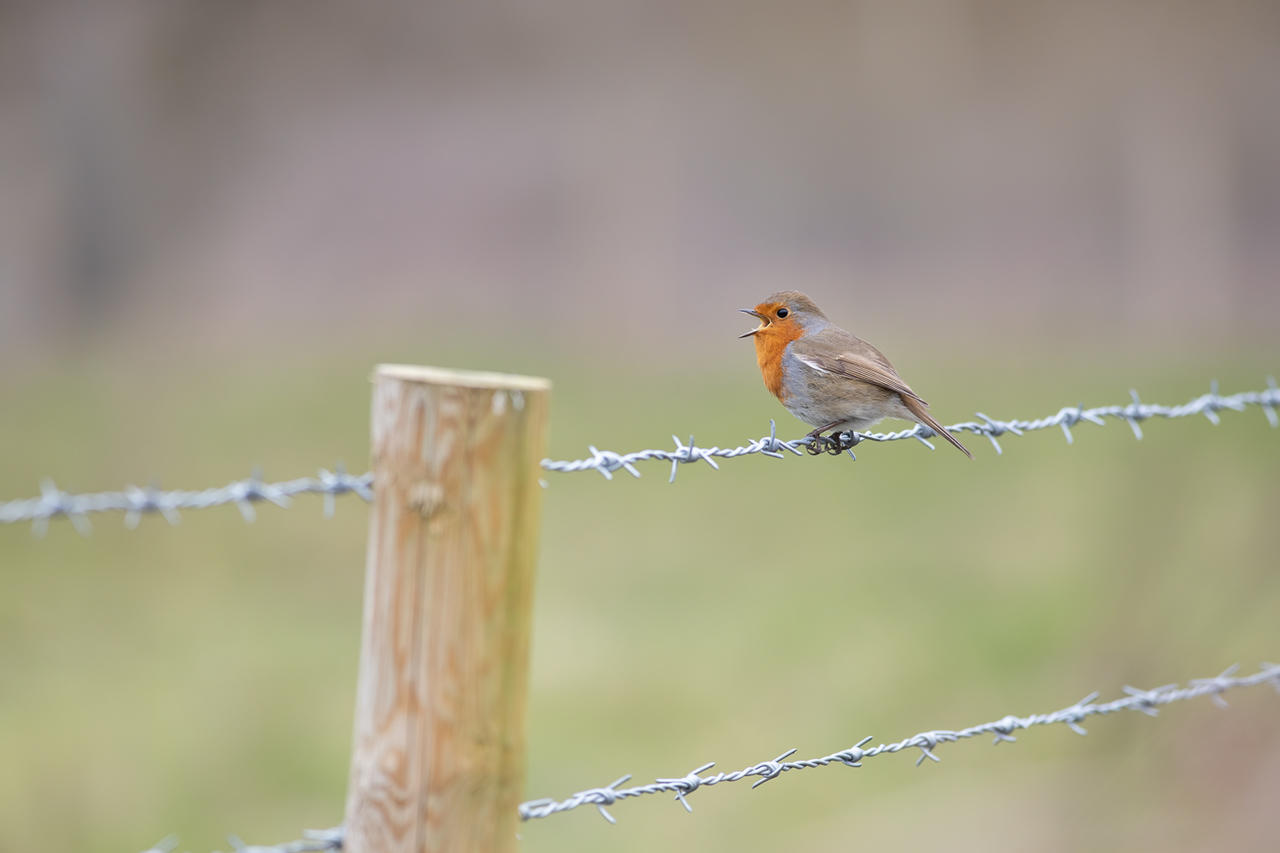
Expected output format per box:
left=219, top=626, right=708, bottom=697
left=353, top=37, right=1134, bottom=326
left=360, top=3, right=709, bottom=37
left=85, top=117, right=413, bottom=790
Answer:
left=0, top=379, right=1280, bottom=534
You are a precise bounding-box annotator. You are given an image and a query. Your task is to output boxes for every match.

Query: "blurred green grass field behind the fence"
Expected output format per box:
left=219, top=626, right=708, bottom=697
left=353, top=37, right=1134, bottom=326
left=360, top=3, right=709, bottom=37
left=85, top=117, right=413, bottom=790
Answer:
left=0, top=350, right=1280, bottom=852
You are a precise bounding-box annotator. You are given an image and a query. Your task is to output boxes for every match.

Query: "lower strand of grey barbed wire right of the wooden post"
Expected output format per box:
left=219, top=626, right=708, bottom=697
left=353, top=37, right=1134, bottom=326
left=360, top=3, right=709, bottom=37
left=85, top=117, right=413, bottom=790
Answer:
left=520, top=663, right=1280, bottom=824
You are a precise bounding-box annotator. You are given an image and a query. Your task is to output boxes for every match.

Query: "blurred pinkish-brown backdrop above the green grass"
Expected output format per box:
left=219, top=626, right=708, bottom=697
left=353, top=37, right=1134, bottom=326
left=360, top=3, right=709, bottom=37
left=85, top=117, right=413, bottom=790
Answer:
left=0, top=0, right=1280, bottom=369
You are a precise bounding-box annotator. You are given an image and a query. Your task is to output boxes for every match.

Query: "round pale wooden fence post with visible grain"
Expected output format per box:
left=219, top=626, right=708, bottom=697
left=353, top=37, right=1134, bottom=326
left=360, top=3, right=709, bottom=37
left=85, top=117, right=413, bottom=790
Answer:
left=343, top=365, right=550, bottom=853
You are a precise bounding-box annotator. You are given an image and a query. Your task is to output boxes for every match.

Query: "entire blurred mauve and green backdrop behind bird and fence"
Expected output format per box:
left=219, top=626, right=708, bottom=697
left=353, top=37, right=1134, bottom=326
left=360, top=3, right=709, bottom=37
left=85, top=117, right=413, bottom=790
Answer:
left=0, top=0, right=1280, bottom=853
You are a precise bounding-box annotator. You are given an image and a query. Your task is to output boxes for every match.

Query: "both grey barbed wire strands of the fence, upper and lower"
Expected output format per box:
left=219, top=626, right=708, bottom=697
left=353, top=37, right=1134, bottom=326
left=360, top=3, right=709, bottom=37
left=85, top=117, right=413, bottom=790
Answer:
left=0, top=379, right=1280, bottom=853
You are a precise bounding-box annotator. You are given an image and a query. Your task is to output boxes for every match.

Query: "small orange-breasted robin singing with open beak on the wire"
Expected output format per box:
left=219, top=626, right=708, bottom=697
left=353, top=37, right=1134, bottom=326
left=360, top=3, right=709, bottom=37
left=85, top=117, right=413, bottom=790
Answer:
left=739, top=291, right=973, bottom=459
